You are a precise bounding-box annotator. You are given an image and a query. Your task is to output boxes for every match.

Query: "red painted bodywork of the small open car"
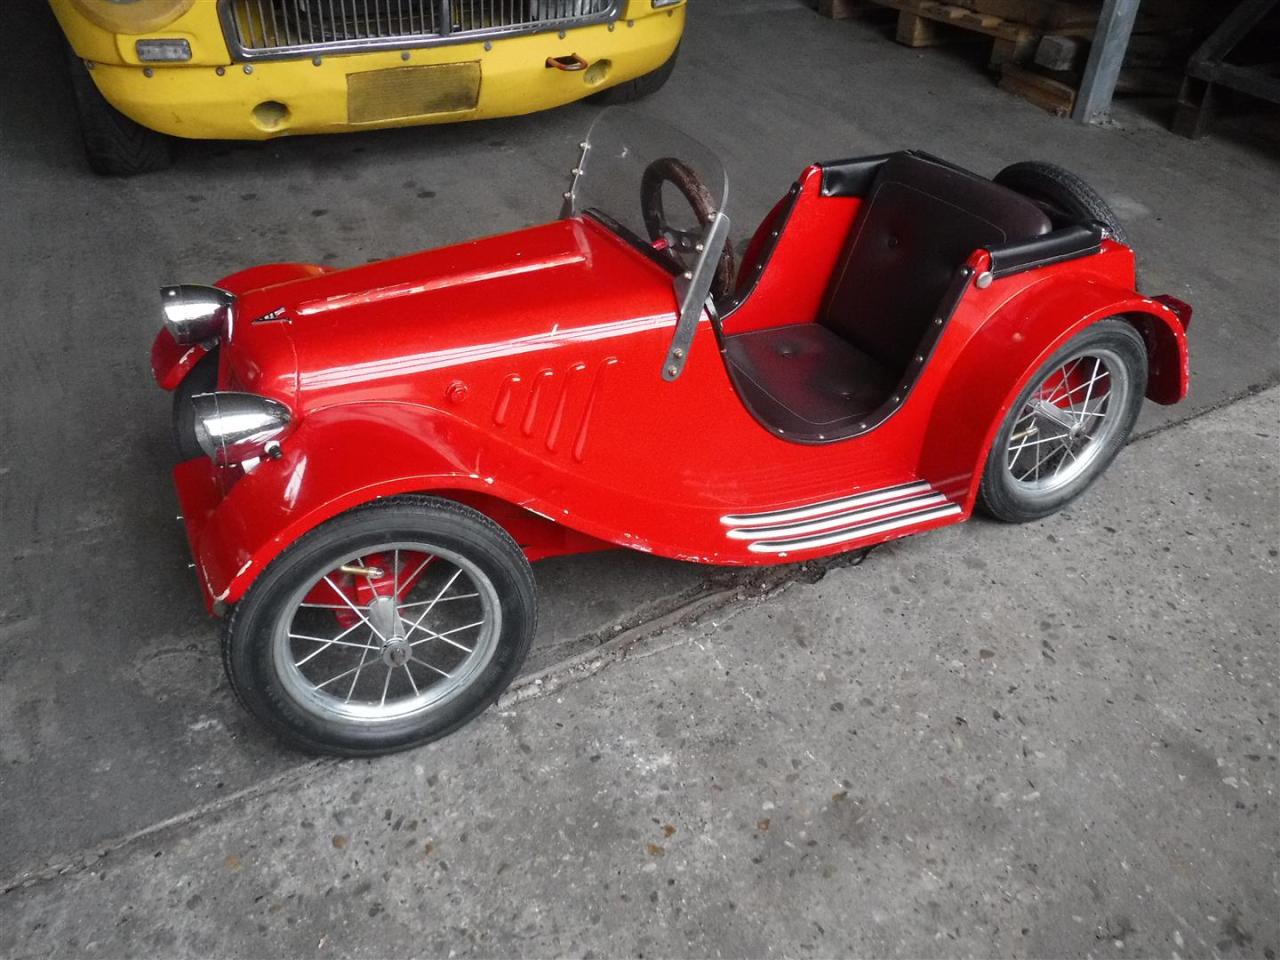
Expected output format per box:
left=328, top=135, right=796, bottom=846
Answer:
left=152, top=168, right=1187, bottom=609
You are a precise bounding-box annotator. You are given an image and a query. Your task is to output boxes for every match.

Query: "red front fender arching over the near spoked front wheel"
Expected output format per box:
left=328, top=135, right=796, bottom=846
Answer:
left=186, top=403, right=612, bottom=611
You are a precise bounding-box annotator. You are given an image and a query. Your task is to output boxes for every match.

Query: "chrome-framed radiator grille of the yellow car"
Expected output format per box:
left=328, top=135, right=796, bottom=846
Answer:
left=218, top=0, right=622, bottom=61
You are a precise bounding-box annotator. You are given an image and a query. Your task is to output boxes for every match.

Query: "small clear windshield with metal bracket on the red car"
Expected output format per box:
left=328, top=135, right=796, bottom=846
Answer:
left=562, top=108, right=728, bottom=380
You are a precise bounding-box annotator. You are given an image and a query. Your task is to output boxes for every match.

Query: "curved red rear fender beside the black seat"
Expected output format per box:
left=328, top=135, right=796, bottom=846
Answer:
left=920, top=273, right=1188, bottom=511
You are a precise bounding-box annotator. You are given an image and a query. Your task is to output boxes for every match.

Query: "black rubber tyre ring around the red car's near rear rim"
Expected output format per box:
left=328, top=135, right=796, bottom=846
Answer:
left=978, top=317, right=1147, bottom=524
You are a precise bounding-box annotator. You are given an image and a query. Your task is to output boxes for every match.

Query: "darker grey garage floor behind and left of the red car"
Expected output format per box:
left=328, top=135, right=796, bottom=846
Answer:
left=0, top=0, right=1280, bottom=931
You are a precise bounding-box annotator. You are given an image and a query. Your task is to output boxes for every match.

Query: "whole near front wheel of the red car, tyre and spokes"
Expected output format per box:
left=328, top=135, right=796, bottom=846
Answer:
left=223, top=497, right=538, bottom=756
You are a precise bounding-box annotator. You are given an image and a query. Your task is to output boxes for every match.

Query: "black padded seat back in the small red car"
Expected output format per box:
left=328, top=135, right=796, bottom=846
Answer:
left=818, top=152, right=1052, bottom=374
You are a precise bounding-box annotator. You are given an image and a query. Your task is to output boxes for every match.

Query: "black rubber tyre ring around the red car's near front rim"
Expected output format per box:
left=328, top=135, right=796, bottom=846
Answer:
left=223, top=495, right=538, bottom=756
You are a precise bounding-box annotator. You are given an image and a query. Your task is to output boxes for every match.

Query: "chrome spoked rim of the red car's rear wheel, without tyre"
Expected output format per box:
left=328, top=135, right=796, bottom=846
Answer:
left=1005, top=347, right=1133, bottom=497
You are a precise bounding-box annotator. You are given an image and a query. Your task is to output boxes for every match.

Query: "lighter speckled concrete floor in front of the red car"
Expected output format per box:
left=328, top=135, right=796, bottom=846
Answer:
left=0, top=389, right=1280, bottom=960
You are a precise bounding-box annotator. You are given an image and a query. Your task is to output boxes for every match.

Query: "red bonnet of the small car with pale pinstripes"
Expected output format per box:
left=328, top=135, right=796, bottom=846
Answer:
left=225, top=219, right=676, bottom=412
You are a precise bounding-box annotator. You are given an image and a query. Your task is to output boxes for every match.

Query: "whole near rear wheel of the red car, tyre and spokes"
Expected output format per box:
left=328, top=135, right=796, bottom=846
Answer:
left=978, top=317, right=1147, bottom=524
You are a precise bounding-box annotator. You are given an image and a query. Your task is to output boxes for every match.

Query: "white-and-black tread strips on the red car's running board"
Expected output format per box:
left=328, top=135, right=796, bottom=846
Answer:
left=721, top=480, right=960, bottom=556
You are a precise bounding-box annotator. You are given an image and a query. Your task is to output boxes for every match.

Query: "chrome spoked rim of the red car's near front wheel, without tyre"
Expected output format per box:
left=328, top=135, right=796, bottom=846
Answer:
left=271, top=541, right=502, bottom=724
